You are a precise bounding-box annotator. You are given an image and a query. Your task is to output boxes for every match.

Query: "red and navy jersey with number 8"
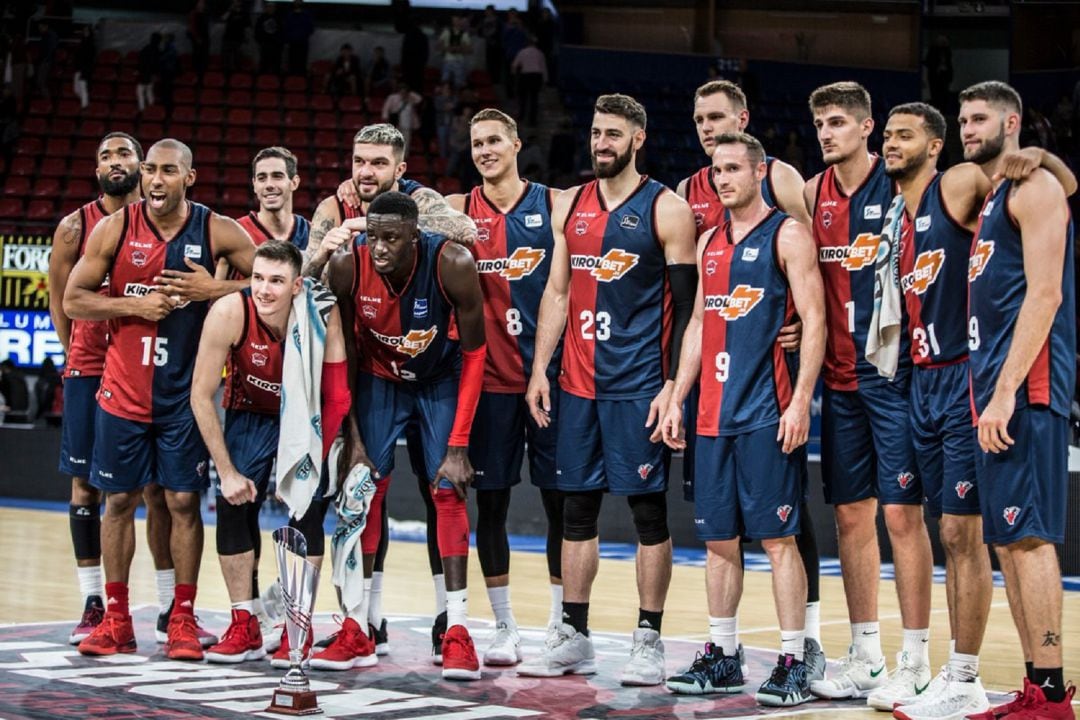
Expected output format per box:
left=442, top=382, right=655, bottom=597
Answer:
left=464, top=182, right=558, bottom=393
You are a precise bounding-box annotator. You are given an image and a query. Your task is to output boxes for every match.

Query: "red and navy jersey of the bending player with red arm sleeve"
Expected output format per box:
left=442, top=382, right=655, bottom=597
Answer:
left=352, top=231, right=460, bottom=382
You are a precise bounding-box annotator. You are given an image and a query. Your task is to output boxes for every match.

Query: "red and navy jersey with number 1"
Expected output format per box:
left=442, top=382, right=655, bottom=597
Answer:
left=813, top=157, right=912, bottom=391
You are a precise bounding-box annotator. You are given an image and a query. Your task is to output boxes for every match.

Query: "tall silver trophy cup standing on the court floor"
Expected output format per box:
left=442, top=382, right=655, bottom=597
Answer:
left=267, top=527, right=322, bottom=715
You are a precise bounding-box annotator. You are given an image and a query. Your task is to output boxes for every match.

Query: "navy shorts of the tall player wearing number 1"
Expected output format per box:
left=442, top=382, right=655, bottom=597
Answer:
left=821, top=378, right=923, bottom=505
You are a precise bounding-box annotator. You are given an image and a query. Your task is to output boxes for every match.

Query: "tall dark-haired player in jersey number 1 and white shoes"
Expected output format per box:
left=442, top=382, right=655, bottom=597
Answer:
left=805, top=82, right=932, bottom=708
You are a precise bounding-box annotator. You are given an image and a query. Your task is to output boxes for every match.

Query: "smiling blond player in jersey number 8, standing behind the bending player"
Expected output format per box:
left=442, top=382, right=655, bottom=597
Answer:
left=446, top=108, right=563, bottom=665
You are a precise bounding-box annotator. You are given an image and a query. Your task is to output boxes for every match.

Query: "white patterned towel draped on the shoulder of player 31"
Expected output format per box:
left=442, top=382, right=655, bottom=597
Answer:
left=866, top=195, right=904, bottom=380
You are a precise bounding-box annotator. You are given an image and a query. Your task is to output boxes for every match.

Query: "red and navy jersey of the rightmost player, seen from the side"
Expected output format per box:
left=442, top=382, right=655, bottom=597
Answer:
left=968, top=180, right=1077, bottom=422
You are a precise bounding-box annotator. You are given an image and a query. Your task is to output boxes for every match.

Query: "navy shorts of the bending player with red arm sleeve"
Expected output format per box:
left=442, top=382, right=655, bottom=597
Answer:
left=354, top=372, right=458, bottom=496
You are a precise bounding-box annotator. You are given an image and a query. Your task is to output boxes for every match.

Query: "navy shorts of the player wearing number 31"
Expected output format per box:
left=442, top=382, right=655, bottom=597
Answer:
left=912, top=361, right=981, bottom=517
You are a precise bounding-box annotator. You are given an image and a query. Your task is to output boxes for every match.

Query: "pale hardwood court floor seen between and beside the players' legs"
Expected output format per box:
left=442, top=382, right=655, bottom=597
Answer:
left=0, top=507, right=1080, bottom=720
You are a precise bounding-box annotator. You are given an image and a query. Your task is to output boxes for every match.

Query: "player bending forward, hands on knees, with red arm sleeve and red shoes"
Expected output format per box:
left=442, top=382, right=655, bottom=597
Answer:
left=321, top=191, right=486, bottom=680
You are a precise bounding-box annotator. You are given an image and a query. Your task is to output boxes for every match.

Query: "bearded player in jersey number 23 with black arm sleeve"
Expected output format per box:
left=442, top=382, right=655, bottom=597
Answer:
left=518, top=95, right=697, bottom=685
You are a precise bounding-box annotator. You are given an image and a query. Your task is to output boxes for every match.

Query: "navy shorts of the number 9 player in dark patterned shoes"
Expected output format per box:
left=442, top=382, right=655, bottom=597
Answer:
left=693, top=424, right=806, bottom=541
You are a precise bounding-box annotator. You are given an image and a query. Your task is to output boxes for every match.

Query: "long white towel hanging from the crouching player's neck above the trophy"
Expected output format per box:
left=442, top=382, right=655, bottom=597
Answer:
left=276, top=277, right=334, bottom=519
